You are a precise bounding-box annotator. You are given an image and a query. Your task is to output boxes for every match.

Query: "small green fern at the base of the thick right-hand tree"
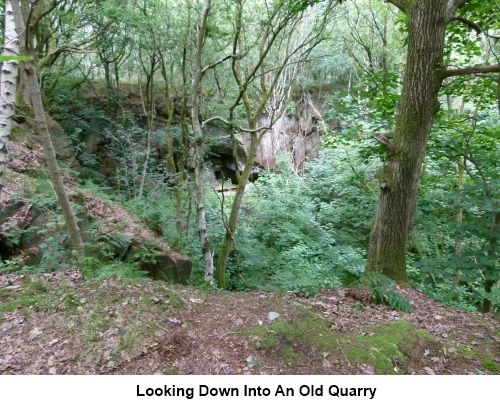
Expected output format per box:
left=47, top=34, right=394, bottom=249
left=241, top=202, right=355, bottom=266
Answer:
left=361, top=272, right=413, bottom=313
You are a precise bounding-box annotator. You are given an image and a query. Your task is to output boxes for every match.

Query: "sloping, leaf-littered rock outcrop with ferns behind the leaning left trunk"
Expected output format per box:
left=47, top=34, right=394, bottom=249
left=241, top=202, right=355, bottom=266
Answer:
left=0, top=143, right=192, bottom=284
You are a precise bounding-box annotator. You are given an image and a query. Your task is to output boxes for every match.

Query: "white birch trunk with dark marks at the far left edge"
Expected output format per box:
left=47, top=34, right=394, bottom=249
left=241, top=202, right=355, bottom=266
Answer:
left=0, top=0, right=20, bottom=191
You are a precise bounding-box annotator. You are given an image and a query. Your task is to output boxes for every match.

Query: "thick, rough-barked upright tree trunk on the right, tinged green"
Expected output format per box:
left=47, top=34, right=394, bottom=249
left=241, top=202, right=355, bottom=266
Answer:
left=367, top=0, right=451, bottom=283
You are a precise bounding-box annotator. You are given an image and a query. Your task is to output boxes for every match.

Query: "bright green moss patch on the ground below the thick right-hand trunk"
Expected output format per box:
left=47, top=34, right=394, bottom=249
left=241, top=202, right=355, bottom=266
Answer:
left=242, top=308, right=436, bottom=374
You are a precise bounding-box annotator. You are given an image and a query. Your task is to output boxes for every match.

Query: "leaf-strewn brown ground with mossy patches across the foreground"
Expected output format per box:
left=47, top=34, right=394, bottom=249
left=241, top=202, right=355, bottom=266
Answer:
left=0, top=269, right=500, bottom=375
